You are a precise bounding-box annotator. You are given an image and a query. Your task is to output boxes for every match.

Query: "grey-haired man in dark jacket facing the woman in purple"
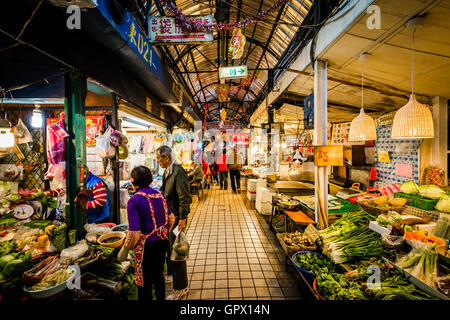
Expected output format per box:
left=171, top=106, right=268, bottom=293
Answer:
left=156, top=146, right=192, bottom=300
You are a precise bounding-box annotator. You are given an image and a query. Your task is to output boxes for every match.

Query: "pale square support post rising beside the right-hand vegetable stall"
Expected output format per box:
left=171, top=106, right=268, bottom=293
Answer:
left=314, top=60, right=328, bottom=228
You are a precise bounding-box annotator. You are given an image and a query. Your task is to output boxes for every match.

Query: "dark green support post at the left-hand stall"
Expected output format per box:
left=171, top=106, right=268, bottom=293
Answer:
left=64, top=72, right=87, bottom=237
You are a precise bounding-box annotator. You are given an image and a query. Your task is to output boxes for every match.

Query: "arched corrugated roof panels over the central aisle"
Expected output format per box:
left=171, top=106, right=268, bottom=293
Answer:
left=151, top=0, right=313, bottom=120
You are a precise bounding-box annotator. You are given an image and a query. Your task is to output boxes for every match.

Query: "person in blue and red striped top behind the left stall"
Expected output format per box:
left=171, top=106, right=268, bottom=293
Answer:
left=75, top=165, right=110, bottom=223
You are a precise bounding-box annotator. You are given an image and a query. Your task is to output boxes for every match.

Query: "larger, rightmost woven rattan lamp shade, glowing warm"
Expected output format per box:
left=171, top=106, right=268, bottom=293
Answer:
left=391, top=94, right=434, bottom=139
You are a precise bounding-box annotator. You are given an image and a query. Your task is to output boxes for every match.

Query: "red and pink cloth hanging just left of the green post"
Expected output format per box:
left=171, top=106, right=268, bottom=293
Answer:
left=45, top=113, right=69, bottom=178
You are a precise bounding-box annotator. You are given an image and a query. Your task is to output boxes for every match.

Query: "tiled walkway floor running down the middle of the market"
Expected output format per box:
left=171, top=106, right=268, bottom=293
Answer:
left=182, top=182, right=300, bottom=300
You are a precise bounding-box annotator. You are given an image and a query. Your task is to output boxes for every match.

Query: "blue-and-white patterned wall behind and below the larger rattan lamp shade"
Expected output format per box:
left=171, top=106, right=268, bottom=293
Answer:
left=375, top=125, right=422, bottom=187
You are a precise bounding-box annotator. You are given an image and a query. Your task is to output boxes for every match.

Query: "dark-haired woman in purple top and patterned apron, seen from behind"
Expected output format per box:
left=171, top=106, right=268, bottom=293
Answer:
left=118, top=166, right=175, bottom=302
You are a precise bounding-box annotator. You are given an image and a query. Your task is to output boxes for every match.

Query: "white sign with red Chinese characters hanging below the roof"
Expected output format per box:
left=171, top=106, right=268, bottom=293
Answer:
left=148, top=15, right=214, bottom=45
